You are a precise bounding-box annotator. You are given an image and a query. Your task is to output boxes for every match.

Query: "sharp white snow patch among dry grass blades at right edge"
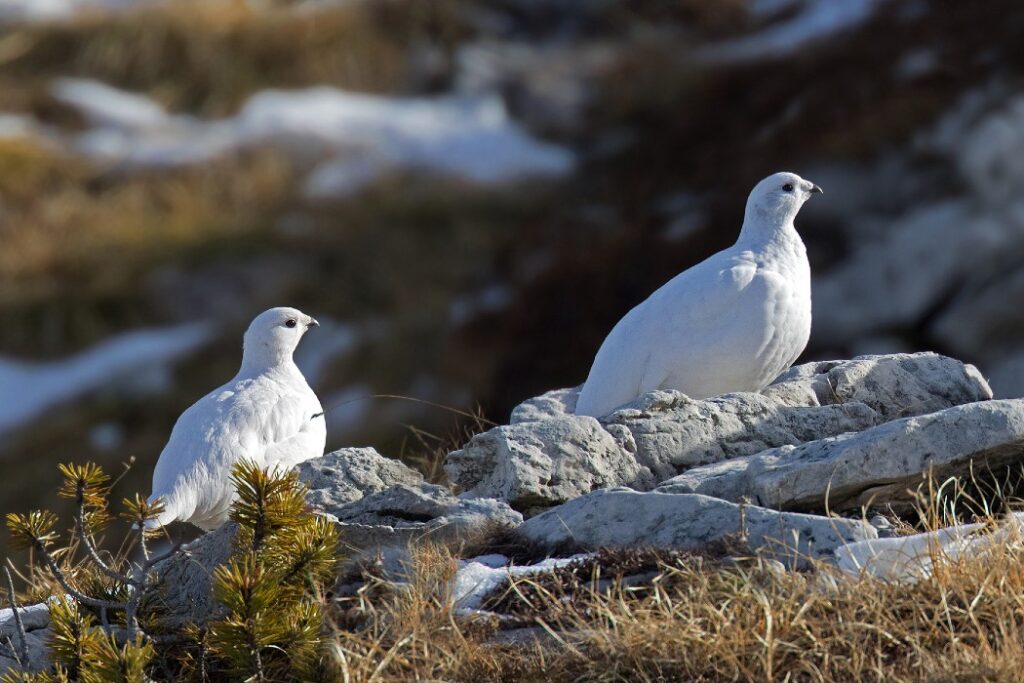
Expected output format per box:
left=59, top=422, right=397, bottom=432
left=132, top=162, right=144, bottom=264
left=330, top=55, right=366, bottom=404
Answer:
left=836, top=512, right=1024, bottom=583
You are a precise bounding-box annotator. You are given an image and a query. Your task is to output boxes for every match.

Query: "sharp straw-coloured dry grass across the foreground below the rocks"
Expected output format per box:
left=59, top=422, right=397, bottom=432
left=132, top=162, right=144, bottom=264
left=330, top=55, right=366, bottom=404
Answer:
left=325, top=532, right=1024, bottom=681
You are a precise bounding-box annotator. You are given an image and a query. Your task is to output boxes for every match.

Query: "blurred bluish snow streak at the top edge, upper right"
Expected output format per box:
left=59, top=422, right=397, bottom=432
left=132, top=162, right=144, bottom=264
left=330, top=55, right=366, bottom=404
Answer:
left=696, top=0, right=886, bottom=62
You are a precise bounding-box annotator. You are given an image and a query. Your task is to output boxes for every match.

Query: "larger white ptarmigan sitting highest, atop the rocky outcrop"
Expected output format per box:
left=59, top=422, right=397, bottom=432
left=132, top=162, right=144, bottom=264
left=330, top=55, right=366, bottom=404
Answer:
left=575, top=173, right=821, bottom=417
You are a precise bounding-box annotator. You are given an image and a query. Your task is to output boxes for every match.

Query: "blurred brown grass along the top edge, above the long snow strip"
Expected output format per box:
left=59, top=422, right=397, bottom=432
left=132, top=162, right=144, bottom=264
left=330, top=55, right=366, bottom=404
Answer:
left=0, top=0, right=465, bottom=119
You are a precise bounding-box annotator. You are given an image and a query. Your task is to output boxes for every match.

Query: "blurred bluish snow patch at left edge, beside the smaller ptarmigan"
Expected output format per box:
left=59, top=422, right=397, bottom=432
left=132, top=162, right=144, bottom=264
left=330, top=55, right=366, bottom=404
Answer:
left=0, top=323, right=212, bottom=433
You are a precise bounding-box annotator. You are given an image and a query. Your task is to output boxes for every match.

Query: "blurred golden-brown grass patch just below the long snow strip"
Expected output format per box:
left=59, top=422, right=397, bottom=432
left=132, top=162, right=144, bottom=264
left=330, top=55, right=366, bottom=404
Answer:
left=0, top=140, right=292, bottom=294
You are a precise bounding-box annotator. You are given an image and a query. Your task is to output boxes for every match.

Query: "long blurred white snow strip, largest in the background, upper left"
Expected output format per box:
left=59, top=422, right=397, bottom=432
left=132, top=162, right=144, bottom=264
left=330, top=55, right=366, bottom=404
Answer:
left=53, top=79, right=574, bottom=198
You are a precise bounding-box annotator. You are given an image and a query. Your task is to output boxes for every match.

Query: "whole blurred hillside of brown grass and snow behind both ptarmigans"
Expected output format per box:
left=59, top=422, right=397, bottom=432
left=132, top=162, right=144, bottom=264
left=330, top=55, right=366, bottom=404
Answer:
left=0, top=0, right=1024, bottom=550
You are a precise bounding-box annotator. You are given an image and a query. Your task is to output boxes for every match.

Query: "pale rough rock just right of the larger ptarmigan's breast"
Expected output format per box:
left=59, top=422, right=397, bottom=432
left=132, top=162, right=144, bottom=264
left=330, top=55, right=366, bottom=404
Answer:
left=762, top=353, right=992, bottom=420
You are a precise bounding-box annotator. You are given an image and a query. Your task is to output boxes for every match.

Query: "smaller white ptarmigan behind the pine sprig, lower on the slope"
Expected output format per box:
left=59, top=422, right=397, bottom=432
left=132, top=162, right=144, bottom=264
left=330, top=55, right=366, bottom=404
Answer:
left=150, top=308, right=327, bottom=530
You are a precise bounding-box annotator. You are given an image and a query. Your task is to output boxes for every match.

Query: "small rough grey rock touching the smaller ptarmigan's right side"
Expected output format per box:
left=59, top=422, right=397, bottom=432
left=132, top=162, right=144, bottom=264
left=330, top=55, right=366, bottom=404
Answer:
left=295, top=449, right=423, bottom=512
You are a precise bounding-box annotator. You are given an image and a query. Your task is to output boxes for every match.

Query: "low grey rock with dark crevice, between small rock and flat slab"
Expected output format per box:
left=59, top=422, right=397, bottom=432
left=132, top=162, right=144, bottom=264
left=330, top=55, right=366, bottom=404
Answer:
left=328, top=483, right=522, bottom=553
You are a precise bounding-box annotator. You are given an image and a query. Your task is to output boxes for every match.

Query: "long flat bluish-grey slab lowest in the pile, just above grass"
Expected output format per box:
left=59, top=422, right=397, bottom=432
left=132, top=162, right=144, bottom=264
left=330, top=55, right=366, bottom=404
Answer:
left=516, top=488, right=878, bottom=566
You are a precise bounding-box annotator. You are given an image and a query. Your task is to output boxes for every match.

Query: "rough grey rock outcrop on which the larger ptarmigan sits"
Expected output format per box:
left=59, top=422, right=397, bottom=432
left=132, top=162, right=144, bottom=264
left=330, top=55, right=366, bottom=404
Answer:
left=445, top=353, right=991, bottom=512
